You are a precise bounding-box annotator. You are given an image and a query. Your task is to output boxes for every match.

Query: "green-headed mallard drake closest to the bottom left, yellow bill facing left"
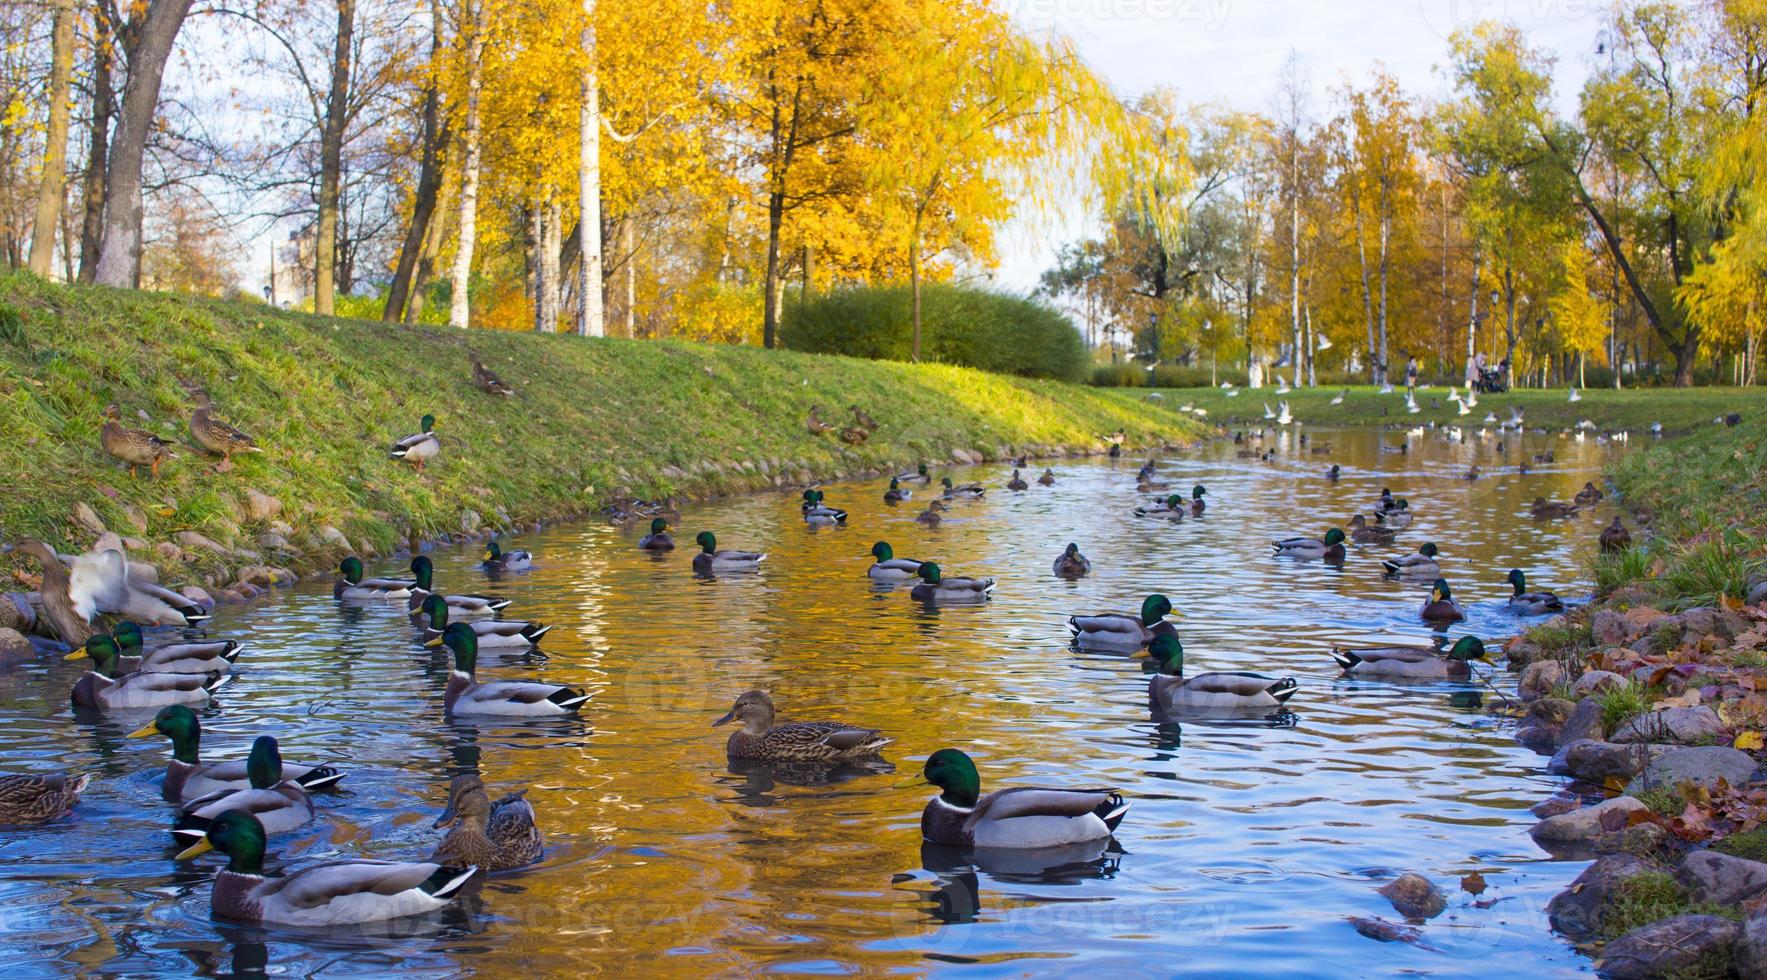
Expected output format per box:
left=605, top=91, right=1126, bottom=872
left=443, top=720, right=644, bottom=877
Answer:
left=178, top=810, right=479, bottom=927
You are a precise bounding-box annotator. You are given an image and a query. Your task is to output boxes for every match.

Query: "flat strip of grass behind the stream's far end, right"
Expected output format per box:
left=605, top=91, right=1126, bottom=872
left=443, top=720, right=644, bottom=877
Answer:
left=1113, top=385, right=1767, bottom=433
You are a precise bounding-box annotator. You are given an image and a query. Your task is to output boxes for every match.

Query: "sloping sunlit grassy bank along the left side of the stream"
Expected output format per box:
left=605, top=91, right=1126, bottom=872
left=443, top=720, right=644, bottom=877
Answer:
left=0, top=274, right=1202, bottom=581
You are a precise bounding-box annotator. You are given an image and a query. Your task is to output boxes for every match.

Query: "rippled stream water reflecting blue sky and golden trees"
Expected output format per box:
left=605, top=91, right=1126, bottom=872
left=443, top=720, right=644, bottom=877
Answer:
left=0, top=431, right=1606, bottom=976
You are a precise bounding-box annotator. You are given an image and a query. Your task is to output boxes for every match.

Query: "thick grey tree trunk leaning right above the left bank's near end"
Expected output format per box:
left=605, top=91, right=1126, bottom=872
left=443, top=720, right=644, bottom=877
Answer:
left=94, top=0, right=191, bottom=286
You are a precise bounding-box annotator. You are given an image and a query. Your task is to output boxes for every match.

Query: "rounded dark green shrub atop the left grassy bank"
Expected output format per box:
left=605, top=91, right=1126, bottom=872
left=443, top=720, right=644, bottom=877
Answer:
left=781, top=284, right=1090, bottom=381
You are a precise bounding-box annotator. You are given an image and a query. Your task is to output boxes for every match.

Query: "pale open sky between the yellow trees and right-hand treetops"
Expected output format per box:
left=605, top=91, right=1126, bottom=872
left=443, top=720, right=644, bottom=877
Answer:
left=995, top=0, right=1610, bottom=290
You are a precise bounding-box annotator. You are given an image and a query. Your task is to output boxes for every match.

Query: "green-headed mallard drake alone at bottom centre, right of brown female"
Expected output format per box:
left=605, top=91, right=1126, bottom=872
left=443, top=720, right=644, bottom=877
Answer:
left=898, top=749, right=1129, bottom=849
